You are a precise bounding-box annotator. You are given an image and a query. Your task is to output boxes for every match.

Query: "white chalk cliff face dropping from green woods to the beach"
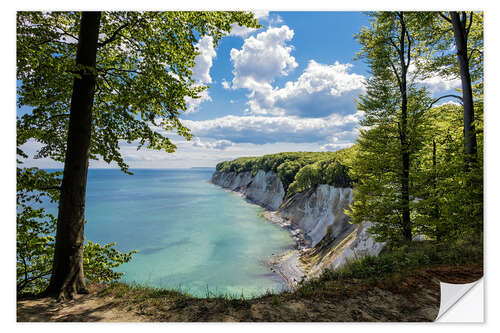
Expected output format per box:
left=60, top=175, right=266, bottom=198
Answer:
left=212, top=170, right=384, bottom=277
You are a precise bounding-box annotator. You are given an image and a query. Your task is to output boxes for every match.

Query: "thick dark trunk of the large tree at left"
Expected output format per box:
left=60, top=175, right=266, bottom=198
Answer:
left=46, top=12, right=101, bottom=299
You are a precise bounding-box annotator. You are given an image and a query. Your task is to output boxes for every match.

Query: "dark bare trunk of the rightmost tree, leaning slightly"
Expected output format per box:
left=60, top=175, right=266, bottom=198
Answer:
left=450, top=12, right=477, bottom=165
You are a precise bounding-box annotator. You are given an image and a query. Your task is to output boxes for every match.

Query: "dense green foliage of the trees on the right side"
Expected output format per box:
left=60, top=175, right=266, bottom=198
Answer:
left=348, top=12, right=483, bottom=241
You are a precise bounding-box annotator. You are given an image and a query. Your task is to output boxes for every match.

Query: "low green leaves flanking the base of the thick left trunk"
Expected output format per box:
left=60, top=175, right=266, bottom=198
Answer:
left=16, top=168, right=135, bottom=293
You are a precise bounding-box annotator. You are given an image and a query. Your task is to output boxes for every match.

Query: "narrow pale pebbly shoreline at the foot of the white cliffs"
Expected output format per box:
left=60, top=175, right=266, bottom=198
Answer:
left=211, top=180, right=310, bottom=290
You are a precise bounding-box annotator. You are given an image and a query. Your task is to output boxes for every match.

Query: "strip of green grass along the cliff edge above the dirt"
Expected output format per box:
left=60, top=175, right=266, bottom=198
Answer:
left=93, top=241, right=483, bottom=309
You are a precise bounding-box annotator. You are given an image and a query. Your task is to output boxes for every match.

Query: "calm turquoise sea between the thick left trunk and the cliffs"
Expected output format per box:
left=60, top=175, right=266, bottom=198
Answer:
left=43, top=169, right=294, bottom=297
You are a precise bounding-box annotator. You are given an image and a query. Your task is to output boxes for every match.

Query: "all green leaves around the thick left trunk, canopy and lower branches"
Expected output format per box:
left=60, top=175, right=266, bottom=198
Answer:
left=16, top=11, right=260, bottom=292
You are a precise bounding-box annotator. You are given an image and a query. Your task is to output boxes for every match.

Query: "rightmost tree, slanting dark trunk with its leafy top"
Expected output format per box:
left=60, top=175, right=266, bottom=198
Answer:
left=419, top=11, right=483, bottom=168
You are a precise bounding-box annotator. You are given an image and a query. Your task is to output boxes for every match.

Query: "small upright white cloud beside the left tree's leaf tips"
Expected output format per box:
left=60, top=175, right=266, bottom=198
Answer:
left=186, top=36, right=217, bottom=113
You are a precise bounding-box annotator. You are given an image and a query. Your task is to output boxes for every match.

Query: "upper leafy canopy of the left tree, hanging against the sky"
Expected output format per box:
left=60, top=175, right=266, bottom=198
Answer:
left=17, top=11, right=259, bottom=171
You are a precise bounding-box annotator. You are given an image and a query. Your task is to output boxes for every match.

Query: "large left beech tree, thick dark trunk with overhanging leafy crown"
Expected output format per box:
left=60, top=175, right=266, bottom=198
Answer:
left=17, top=12, right=259, bottom=299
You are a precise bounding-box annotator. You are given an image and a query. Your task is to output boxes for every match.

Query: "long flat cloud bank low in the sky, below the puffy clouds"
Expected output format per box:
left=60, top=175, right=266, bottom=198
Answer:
left=183, top=111, right=363, bottom=144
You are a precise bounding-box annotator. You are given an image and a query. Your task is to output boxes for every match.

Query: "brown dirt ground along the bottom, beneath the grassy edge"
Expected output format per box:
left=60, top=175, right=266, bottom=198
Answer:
left=17, top=265, right=483, bottom=322
